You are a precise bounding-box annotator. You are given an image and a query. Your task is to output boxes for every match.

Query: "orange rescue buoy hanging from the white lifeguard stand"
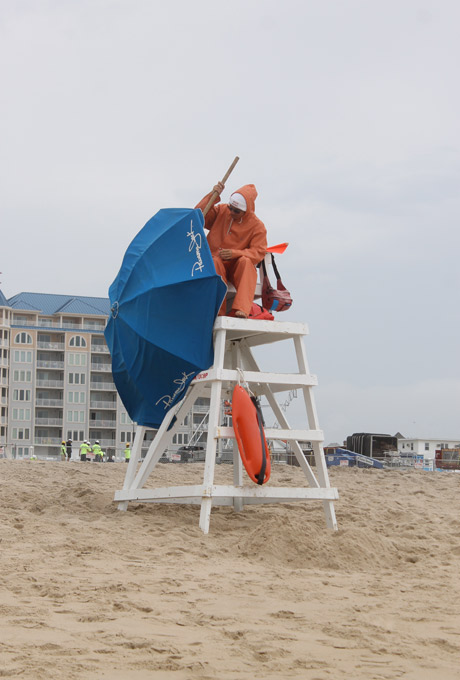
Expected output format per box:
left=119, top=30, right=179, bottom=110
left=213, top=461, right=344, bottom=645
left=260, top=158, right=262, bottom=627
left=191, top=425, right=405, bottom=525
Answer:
left=232, top=385, right=271, bottom=484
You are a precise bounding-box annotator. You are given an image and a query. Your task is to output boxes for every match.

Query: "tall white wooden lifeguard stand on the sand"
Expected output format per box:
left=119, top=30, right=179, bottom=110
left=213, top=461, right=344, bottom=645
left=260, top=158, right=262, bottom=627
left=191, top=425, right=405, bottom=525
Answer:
left=114, top=316, right=338, bottom=534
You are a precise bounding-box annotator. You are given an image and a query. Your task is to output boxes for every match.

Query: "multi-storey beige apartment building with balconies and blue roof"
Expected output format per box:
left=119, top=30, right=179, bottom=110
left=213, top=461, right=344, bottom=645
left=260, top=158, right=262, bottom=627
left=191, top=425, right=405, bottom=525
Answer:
left=0, top=292, right=144, bottom=458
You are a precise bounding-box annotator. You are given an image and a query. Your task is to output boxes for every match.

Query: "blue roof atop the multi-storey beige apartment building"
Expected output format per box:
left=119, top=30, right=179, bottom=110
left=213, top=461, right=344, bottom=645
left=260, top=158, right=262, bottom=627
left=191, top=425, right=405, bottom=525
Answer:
left=7, top=293, right=110, bottom=316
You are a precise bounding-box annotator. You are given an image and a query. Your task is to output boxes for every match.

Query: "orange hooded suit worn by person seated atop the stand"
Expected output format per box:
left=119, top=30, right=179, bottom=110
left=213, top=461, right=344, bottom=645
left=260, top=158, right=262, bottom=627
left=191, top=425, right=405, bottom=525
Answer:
left=196, top=184, right=267, bottom=315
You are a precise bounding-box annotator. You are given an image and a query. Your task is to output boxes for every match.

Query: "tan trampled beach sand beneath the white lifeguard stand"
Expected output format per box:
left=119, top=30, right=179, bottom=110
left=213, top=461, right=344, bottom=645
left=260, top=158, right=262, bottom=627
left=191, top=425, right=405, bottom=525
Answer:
left=0, top=460, right=460, bottom=680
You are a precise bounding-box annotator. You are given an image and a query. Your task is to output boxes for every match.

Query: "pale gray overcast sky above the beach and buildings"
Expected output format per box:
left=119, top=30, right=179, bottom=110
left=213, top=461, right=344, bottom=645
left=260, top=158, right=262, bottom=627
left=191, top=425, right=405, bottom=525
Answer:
left=0, top=0, right=460, bottom=442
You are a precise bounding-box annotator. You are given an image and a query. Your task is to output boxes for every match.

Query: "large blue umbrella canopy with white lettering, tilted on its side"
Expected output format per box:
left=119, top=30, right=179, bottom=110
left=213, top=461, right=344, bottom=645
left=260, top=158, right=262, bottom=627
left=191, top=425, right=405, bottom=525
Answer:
left=104, top=208, right=227, bottom=427
